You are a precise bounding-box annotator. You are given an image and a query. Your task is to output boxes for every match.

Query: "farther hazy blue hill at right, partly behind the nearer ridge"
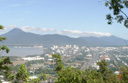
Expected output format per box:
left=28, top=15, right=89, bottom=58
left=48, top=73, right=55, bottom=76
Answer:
left=80, top=36, right=128, bottom=46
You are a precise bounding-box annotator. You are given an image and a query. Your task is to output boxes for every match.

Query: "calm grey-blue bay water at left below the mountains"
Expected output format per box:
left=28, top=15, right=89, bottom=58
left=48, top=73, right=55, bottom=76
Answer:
left=1, top=46, right=43, bottom=57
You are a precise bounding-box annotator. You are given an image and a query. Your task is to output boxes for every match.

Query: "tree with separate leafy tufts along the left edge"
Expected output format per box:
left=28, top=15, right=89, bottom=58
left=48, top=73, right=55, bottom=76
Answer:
left=0, top=25, right=14, bottom=80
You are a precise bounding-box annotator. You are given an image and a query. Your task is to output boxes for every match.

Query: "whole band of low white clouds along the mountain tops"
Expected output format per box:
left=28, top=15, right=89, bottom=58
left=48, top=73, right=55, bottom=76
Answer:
left=0, top=25, right=111, bottom=37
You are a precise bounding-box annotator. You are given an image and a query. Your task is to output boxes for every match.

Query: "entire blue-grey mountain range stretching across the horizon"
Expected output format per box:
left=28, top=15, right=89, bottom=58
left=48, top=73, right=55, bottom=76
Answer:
left=1, top=28, right=128, bottom=46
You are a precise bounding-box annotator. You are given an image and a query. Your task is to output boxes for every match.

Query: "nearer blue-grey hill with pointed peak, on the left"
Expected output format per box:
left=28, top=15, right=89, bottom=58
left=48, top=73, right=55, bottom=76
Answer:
left=2, top=28, right=91, bottom=46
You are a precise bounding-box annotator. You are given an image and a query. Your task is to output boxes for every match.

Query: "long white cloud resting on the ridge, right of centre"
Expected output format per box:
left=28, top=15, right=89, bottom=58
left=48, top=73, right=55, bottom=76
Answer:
left=57, top=29, right=111, bottom=37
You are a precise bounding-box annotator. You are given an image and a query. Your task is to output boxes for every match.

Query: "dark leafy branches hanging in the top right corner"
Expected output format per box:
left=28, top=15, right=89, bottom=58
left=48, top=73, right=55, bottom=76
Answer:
left=105, top=0, right=128, bottom=28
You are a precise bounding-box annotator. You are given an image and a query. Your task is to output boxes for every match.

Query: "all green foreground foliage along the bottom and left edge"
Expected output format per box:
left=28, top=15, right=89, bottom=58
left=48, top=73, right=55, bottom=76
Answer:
left=0, top=25, right=128, bottom=83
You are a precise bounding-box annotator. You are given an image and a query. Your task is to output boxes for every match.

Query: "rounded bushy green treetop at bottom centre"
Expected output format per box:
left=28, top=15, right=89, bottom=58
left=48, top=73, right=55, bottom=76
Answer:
left=56, top=66, right=82, bottom=83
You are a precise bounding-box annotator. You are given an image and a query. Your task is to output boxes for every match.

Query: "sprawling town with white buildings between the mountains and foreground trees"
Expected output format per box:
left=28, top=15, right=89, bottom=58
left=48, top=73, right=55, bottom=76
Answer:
left=1, top=45, right=128, bottom=83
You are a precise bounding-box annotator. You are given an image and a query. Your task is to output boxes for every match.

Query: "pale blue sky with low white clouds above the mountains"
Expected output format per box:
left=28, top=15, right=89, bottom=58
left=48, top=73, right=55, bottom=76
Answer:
left=0, top=0, right=128, bottom=39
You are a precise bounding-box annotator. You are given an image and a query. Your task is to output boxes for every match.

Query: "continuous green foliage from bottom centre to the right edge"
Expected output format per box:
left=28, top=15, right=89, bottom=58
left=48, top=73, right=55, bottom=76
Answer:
left=53, top=54, right=128, bottom=83
